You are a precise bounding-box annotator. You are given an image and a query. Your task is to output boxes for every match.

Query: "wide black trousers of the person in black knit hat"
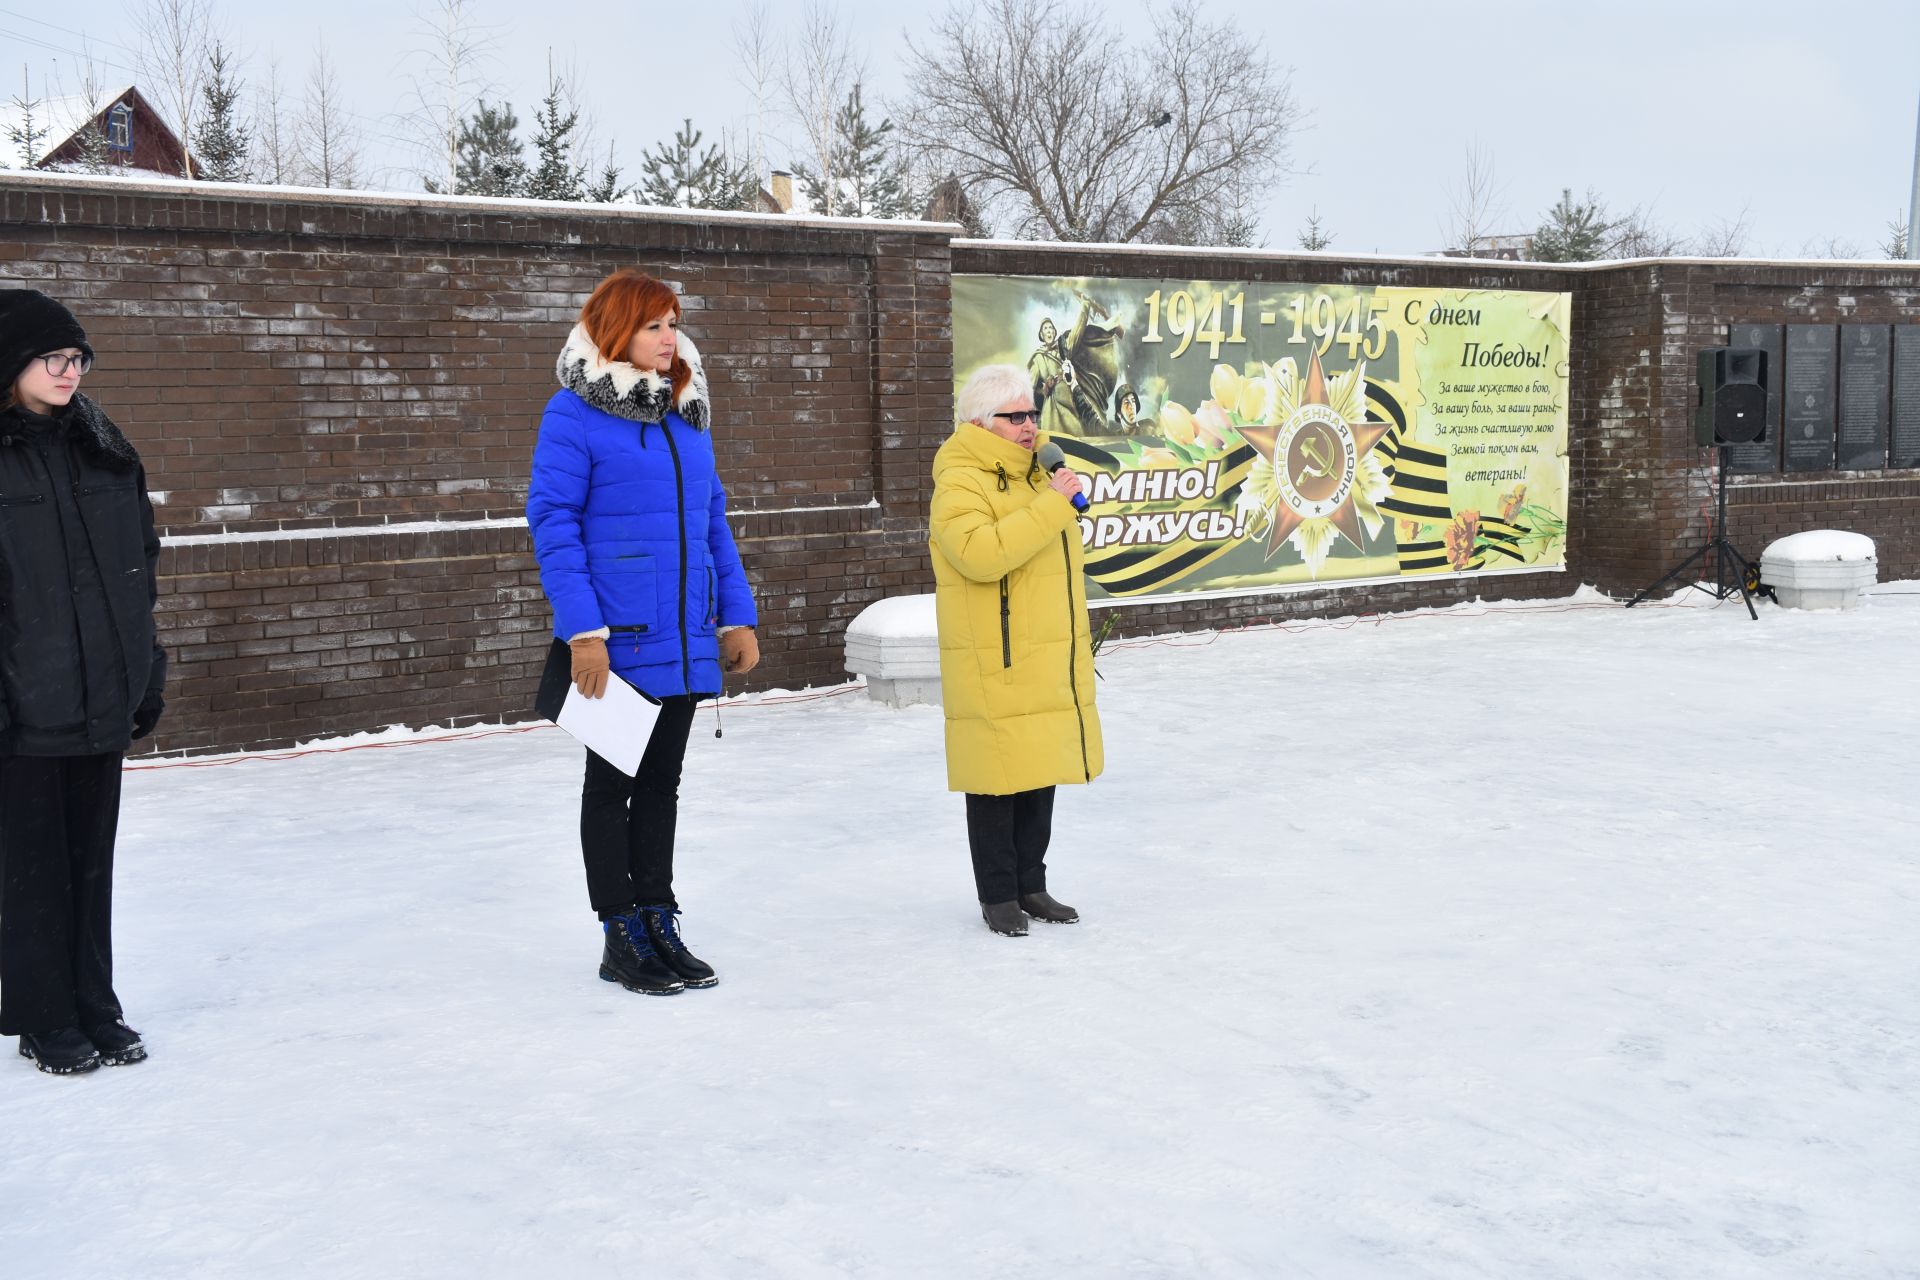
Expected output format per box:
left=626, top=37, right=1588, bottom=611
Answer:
left=0, top=752, right=121, bottom=1036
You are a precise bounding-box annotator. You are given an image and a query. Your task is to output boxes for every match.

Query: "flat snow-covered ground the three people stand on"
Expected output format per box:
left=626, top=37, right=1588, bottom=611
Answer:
left=0, top=585, right=1920, bottom=1280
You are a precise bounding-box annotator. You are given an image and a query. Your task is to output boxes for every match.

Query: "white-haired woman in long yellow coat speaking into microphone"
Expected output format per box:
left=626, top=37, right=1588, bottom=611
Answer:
left=929, top=365, right=1102, bottom=936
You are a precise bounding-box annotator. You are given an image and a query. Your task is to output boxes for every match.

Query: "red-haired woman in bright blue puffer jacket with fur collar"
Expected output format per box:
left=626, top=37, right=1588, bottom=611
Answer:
left=526, top=271, right=760, bottom=996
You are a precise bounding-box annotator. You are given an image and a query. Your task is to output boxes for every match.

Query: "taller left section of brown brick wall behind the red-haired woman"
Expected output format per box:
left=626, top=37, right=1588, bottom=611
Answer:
left=0, top=175, right=952, bottom=750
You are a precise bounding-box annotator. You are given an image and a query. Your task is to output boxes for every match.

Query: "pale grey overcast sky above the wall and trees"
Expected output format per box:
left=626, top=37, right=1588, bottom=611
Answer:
left=0, top=0, right=1920, bottom=255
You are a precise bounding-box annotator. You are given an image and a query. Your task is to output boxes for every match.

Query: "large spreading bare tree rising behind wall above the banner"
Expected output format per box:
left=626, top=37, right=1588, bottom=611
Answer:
left=899, top=0, right=1302, bottom=242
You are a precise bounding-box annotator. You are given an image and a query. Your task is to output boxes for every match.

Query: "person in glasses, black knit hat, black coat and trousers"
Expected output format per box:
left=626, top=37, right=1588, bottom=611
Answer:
left=0, top=290, right=167, bottom=1075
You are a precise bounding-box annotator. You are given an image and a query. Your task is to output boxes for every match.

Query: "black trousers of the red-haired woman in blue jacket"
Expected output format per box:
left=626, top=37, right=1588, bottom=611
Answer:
left=580, top=695, right=699, bottom=919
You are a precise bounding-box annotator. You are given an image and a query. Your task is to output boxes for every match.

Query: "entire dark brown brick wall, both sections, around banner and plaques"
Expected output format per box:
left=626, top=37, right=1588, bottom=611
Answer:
left=11, top=175, right=1920, bottom=750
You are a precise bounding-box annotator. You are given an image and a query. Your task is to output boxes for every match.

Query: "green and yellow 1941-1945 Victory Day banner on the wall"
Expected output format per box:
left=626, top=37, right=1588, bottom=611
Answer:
left=952, top=274, right=1571, bottom=599
